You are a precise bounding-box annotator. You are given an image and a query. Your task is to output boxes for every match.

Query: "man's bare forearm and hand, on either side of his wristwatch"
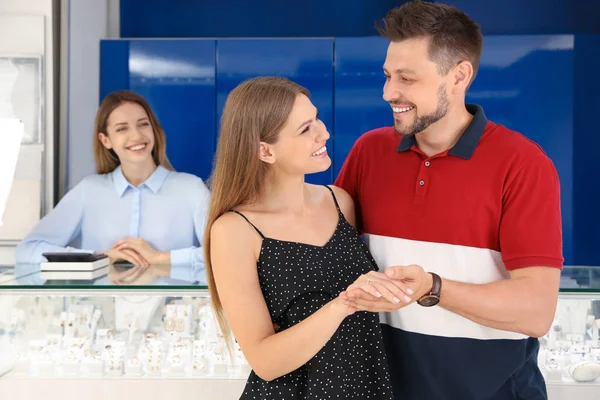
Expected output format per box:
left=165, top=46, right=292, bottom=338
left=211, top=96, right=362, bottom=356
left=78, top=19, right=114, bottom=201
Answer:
left=347, top=265, right=560, bottom=337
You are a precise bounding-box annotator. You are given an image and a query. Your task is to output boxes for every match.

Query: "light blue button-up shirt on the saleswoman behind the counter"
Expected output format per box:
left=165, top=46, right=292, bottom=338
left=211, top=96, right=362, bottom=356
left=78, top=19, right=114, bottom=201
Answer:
left=15, top=166, right=210, bottom=277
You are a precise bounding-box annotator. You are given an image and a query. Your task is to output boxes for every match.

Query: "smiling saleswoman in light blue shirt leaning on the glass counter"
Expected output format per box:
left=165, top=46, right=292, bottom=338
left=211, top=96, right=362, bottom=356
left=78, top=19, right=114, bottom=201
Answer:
left=16, top=91, right=209, bottom=282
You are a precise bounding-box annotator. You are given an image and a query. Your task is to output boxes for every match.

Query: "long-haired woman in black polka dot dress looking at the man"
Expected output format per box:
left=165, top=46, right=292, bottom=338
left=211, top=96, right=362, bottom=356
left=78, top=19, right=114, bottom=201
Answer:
left=204, top=77, right=410, bottom=400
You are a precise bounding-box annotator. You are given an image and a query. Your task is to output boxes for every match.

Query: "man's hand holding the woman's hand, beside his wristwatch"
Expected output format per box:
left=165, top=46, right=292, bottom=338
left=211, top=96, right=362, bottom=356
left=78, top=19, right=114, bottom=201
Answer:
left=346, top=265, right=433, bottom=312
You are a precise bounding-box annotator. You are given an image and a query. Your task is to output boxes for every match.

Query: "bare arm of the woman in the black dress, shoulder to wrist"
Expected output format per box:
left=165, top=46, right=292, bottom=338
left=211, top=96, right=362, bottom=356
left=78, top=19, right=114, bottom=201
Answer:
left=210, top=213, right=354, bottom=381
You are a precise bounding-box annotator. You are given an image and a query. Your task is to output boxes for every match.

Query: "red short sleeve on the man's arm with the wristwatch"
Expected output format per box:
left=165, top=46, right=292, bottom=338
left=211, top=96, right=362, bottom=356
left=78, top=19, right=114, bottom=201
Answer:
left=500, top=157, right=564, bottom=271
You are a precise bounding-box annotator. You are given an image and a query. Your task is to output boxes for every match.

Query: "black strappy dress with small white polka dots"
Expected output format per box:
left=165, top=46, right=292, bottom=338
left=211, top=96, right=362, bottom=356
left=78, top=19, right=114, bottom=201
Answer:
left=231, top=188, right=393, bottom=400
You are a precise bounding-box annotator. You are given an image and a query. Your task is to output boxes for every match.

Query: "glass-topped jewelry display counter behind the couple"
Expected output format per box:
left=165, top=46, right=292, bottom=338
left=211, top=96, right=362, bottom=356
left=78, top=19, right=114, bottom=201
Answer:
left=0, top=265, right=600, bottom=400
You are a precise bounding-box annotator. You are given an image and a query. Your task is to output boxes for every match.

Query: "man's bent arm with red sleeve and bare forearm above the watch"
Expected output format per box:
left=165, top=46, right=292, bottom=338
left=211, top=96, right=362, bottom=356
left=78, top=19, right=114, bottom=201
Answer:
left=440, top=155, right=563, bottom=337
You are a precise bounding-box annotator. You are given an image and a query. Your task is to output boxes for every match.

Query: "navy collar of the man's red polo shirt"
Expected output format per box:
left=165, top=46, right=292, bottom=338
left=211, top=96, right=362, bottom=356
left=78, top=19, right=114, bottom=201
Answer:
left=397, top=104, right=487, bottom=160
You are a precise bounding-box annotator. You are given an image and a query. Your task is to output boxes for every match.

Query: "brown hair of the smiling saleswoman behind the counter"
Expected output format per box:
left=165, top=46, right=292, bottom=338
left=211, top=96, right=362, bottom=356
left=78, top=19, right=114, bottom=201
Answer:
left=94, top=90, right=173, bottom=174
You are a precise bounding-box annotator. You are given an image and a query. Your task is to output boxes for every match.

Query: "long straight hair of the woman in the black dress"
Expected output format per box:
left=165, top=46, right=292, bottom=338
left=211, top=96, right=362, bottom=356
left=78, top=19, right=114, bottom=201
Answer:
left=204, top=77, right=309, bottom=348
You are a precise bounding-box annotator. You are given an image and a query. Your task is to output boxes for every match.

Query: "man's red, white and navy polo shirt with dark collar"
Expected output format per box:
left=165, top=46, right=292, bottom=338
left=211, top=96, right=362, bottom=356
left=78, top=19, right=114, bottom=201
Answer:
left=335, top=105, right=563, bottom=400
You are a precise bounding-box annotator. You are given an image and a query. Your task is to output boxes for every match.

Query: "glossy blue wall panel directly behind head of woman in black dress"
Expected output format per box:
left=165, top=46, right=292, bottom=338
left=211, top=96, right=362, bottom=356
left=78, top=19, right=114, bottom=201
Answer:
left=217, top=39, right=335, bottom=184
